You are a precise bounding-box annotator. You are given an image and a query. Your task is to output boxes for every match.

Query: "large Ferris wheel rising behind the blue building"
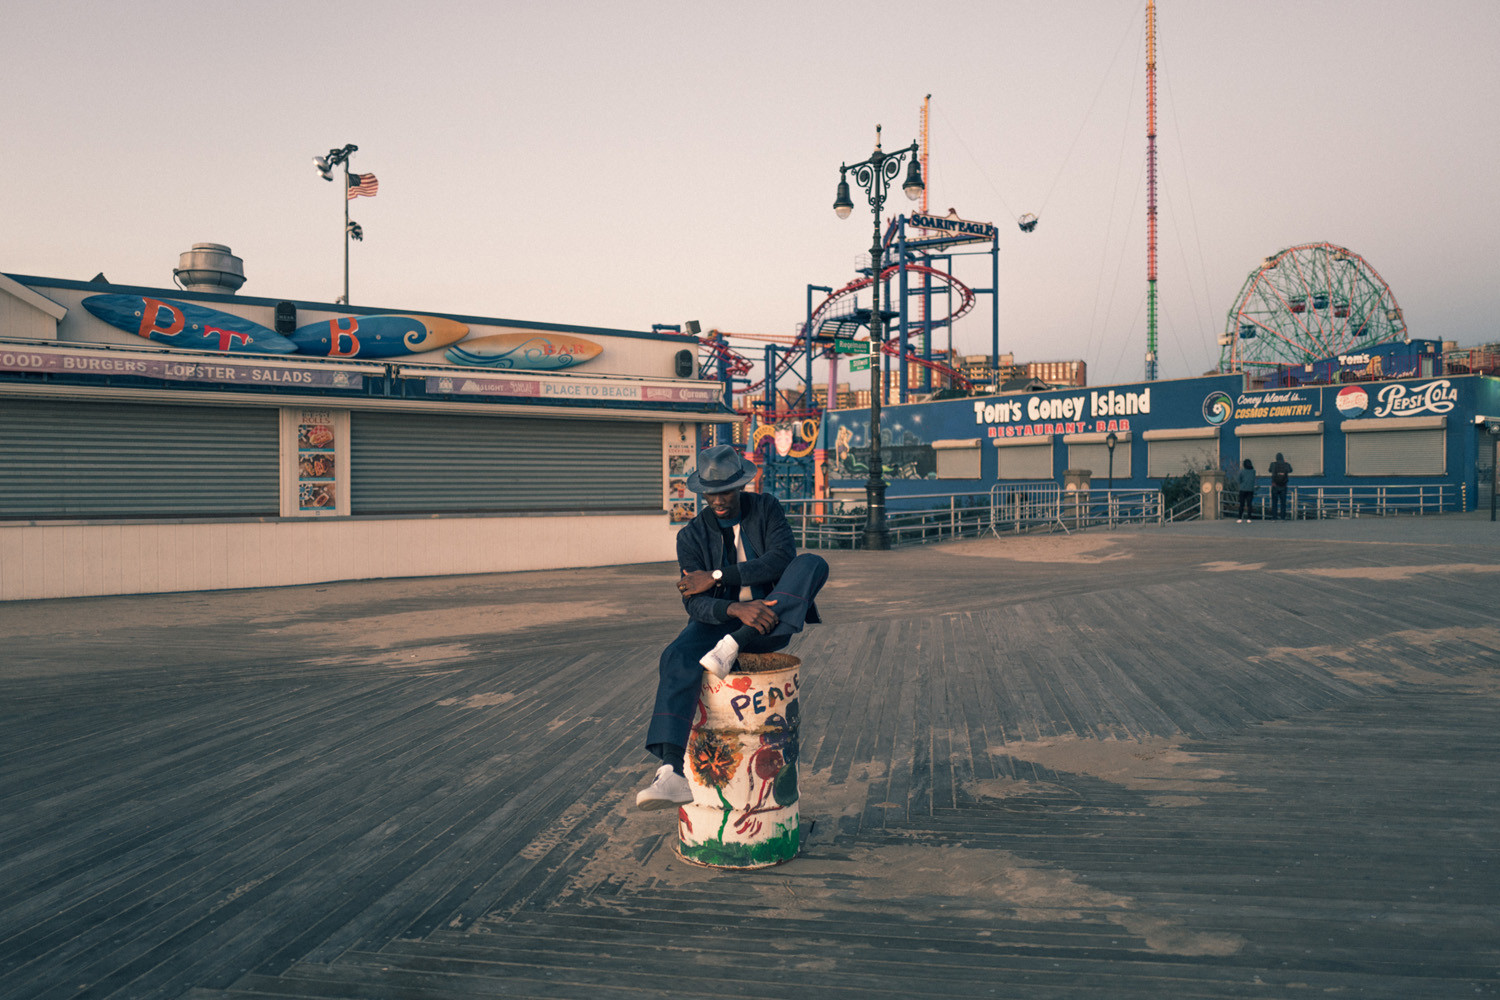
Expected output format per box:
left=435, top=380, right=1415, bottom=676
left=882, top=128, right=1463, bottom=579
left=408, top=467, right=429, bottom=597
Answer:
left=1220, top=243, right=1409, bottom=372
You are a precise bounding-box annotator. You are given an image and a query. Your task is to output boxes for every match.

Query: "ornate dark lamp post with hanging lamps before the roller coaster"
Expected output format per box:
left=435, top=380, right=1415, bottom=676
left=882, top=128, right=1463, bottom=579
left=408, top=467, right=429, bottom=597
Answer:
left=834, top=126, right=923, bottom=549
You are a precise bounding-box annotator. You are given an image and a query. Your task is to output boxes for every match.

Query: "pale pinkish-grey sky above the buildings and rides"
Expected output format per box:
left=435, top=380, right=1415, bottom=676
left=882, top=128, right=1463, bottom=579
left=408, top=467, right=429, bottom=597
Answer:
left=0, top=0, right=1500, bottom=384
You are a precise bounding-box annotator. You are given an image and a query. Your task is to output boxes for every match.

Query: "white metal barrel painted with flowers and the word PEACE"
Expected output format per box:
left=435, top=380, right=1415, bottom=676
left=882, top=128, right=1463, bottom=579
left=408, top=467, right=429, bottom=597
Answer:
left=677, top=652, right=803, bottom=868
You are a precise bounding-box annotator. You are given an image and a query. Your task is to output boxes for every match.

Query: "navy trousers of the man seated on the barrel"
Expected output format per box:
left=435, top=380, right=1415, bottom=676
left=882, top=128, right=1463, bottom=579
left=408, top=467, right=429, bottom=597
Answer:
left=647, top=552, right=828, bottom=748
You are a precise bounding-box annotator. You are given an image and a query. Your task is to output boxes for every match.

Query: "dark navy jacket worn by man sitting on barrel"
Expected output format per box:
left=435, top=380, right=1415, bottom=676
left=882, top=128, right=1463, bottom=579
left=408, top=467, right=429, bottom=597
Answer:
left=677, top=493, right=822, bottom=625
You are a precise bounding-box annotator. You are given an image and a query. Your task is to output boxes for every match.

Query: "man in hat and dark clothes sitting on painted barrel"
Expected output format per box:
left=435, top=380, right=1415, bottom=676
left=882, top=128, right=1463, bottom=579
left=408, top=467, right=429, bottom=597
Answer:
left=636, top=445, right=828, bottom=810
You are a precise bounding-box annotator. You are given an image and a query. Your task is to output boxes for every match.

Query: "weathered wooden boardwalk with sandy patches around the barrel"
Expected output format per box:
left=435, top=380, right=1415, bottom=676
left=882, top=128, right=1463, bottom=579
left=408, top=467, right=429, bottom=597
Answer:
left=0, top=517, right=1500, bottom=1000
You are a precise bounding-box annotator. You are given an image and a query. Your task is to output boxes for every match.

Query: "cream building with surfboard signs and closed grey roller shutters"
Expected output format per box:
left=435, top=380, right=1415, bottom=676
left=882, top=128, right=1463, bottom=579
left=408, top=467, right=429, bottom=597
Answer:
left=0, top=260, right=731, bottom=600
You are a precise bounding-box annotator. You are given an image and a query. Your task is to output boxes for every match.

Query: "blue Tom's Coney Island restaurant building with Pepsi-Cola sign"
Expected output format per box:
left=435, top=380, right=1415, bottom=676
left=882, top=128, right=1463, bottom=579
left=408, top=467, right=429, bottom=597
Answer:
left=822, top=375, right=1500, bottom=508
